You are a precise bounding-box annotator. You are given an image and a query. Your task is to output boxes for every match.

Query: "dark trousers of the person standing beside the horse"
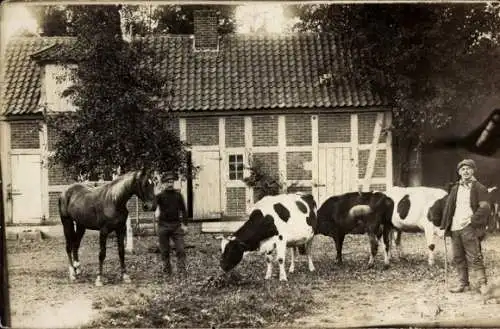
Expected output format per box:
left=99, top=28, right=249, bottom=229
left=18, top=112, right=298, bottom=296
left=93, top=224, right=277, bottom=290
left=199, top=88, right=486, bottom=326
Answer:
left=158, top=222, right=186, bottom=273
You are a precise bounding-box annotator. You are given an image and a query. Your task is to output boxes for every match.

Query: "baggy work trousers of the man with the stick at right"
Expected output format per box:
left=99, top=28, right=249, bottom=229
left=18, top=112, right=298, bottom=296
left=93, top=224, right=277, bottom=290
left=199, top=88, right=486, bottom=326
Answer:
left=451, top=224, right=487, bottom=286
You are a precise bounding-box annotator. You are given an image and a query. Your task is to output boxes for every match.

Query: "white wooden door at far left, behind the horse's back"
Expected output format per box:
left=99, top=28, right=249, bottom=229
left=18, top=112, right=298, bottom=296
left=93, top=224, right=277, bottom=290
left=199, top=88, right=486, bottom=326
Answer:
left=11, top=154, right=43, bottom=223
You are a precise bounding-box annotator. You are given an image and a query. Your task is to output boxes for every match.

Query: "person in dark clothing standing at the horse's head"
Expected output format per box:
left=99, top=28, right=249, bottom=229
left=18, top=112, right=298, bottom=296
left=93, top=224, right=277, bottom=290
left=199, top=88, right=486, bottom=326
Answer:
left=156, top=173, right=187, bottom=274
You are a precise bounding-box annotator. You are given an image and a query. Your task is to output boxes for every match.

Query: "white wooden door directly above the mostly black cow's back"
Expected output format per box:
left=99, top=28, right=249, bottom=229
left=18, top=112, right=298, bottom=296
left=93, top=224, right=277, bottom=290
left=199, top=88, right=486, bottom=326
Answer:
left=317, top=146, right=357, bottom=204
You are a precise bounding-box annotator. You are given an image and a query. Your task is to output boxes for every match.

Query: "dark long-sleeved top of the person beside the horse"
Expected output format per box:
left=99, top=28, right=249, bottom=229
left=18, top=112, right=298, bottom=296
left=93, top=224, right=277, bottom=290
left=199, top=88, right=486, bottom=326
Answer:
left=156, top=189, right=187, bottom=225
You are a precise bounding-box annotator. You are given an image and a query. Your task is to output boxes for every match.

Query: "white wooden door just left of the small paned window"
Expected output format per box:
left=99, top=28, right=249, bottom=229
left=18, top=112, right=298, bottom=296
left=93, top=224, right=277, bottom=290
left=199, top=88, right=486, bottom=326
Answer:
left=192, top=151, right=222, bottom=219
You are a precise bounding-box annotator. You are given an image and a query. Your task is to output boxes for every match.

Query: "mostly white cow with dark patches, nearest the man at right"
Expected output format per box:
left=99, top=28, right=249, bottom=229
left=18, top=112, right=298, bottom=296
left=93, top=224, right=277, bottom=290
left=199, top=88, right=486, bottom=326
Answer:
left=385, top=186, right=447, bottom=266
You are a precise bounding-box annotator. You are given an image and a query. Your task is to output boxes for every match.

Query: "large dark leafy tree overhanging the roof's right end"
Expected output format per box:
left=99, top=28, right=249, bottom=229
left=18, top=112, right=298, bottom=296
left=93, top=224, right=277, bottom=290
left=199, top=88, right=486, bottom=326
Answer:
left=296, top=3, right=500, bottom=184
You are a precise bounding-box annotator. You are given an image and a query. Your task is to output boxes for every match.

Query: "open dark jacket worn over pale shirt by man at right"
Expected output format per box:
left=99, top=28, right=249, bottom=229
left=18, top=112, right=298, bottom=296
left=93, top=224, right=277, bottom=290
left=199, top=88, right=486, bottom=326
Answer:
left=440, top=181, right=490, bottom=238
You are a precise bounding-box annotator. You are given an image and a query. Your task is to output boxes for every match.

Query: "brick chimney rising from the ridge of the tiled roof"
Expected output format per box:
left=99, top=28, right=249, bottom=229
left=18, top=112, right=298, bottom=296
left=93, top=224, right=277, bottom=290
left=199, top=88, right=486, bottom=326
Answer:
left=194, top=10, right=219, bottom=51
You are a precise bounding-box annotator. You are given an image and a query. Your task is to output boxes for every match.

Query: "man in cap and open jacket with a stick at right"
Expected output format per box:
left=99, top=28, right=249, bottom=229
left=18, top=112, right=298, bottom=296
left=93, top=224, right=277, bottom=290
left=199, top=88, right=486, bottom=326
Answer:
left=440, top=159, right=490, bottom=293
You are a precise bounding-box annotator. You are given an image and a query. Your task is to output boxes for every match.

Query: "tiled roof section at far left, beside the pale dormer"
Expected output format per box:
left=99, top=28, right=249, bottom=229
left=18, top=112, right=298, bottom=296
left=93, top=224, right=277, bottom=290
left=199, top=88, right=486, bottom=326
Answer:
left=0, top=37, right=71, bottom=114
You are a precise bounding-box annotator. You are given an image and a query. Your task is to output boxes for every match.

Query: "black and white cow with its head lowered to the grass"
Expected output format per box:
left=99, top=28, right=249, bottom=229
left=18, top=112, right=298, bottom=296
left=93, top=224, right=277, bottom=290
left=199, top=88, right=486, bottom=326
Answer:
left=220, top=193, right=317, bottom=281
